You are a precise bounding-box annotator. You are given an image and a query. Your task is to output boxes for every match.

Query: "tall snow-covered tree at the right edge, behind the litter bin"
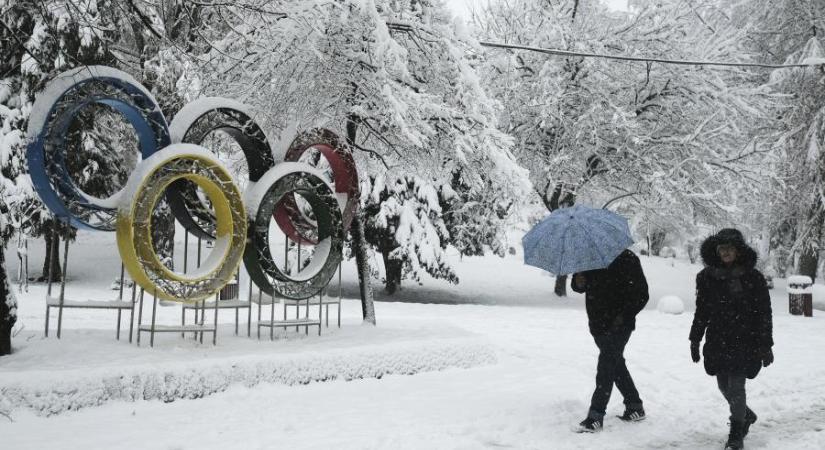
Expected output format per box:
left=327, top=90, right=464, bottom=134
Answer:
left=740, top=0, right=825, bottom=278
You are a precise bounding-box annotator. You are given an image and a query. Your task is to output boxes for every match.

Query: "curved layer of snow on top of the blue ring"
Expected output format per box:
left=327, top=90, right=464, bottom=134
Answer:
left=26, top=66, right=157, bottom=139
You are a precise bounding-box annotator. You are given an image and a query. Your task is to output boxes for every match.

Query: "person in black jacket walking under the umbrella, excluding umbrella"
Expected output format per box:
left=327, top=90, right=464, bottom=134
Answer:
left=572, top=250, right=649, bottom=432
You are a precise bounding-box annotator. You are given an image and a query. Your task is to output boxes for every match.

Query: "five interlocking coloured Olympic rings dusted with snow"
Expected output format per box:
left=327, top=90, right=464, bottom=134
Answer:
left=26, top=66, right=359, bottom=302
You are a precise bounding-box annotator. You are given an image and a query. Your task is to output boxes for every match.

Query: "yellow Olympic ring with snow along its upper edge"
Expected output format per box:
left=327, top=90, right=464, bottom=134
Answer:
left=116, top=144, right=247, bottom=302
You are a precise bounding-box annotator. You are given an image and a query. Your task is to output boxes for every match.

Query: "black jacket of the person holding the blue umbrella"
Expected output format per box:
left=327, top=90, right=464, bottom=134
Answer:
left=571, top=250, right=649, bottom=336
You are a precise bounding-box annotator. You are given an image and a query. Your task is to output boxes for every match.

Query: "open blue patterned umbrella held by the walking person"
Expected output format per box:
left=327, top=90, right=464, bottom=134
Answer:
left=521, top=205, right=633, bottom=275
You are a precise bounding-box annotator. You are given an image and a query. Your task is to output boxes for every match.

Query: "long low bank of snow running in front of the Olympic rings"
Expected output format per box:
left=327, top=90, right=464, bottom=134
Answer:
left=0, top=337, right=498, bottom=416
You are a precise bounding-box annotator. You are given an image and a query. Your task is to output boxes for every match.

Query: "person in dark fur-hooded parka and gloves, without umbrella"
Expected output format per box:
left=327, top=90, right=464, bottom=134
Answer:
left=690, top=228, right=773, bottom=449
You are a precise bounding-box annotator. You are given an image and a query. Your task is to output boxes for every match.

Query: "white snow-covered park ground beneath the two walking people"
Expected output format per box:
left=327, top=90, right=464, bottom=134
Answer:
left=0, top=233, right=825, bottom=450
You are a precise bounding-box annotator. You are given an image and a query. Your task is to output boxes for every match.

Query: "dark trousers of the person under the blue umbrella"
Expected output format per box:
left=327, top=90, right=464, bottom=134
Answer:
left=588, top=331, right=642, bottom=419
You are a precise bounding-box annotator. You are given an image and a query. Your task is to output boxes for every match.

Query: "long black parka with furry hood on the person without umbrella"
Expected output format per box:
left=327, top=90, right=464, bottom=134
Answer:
left=690, top=228, right=773, bottom=378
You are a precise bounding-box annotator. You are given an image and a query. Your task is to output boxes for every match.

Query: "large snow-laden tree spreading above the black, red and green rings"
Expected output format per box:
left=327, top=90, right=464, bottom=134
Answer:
left=174, top=0, right=526, bottom=296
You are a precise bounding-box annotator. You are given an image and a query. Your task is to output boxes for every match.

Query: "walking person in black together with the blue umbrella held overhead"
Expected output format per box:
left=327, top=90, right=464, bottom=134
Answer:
left=522, top=205, right=649, bottom=433
